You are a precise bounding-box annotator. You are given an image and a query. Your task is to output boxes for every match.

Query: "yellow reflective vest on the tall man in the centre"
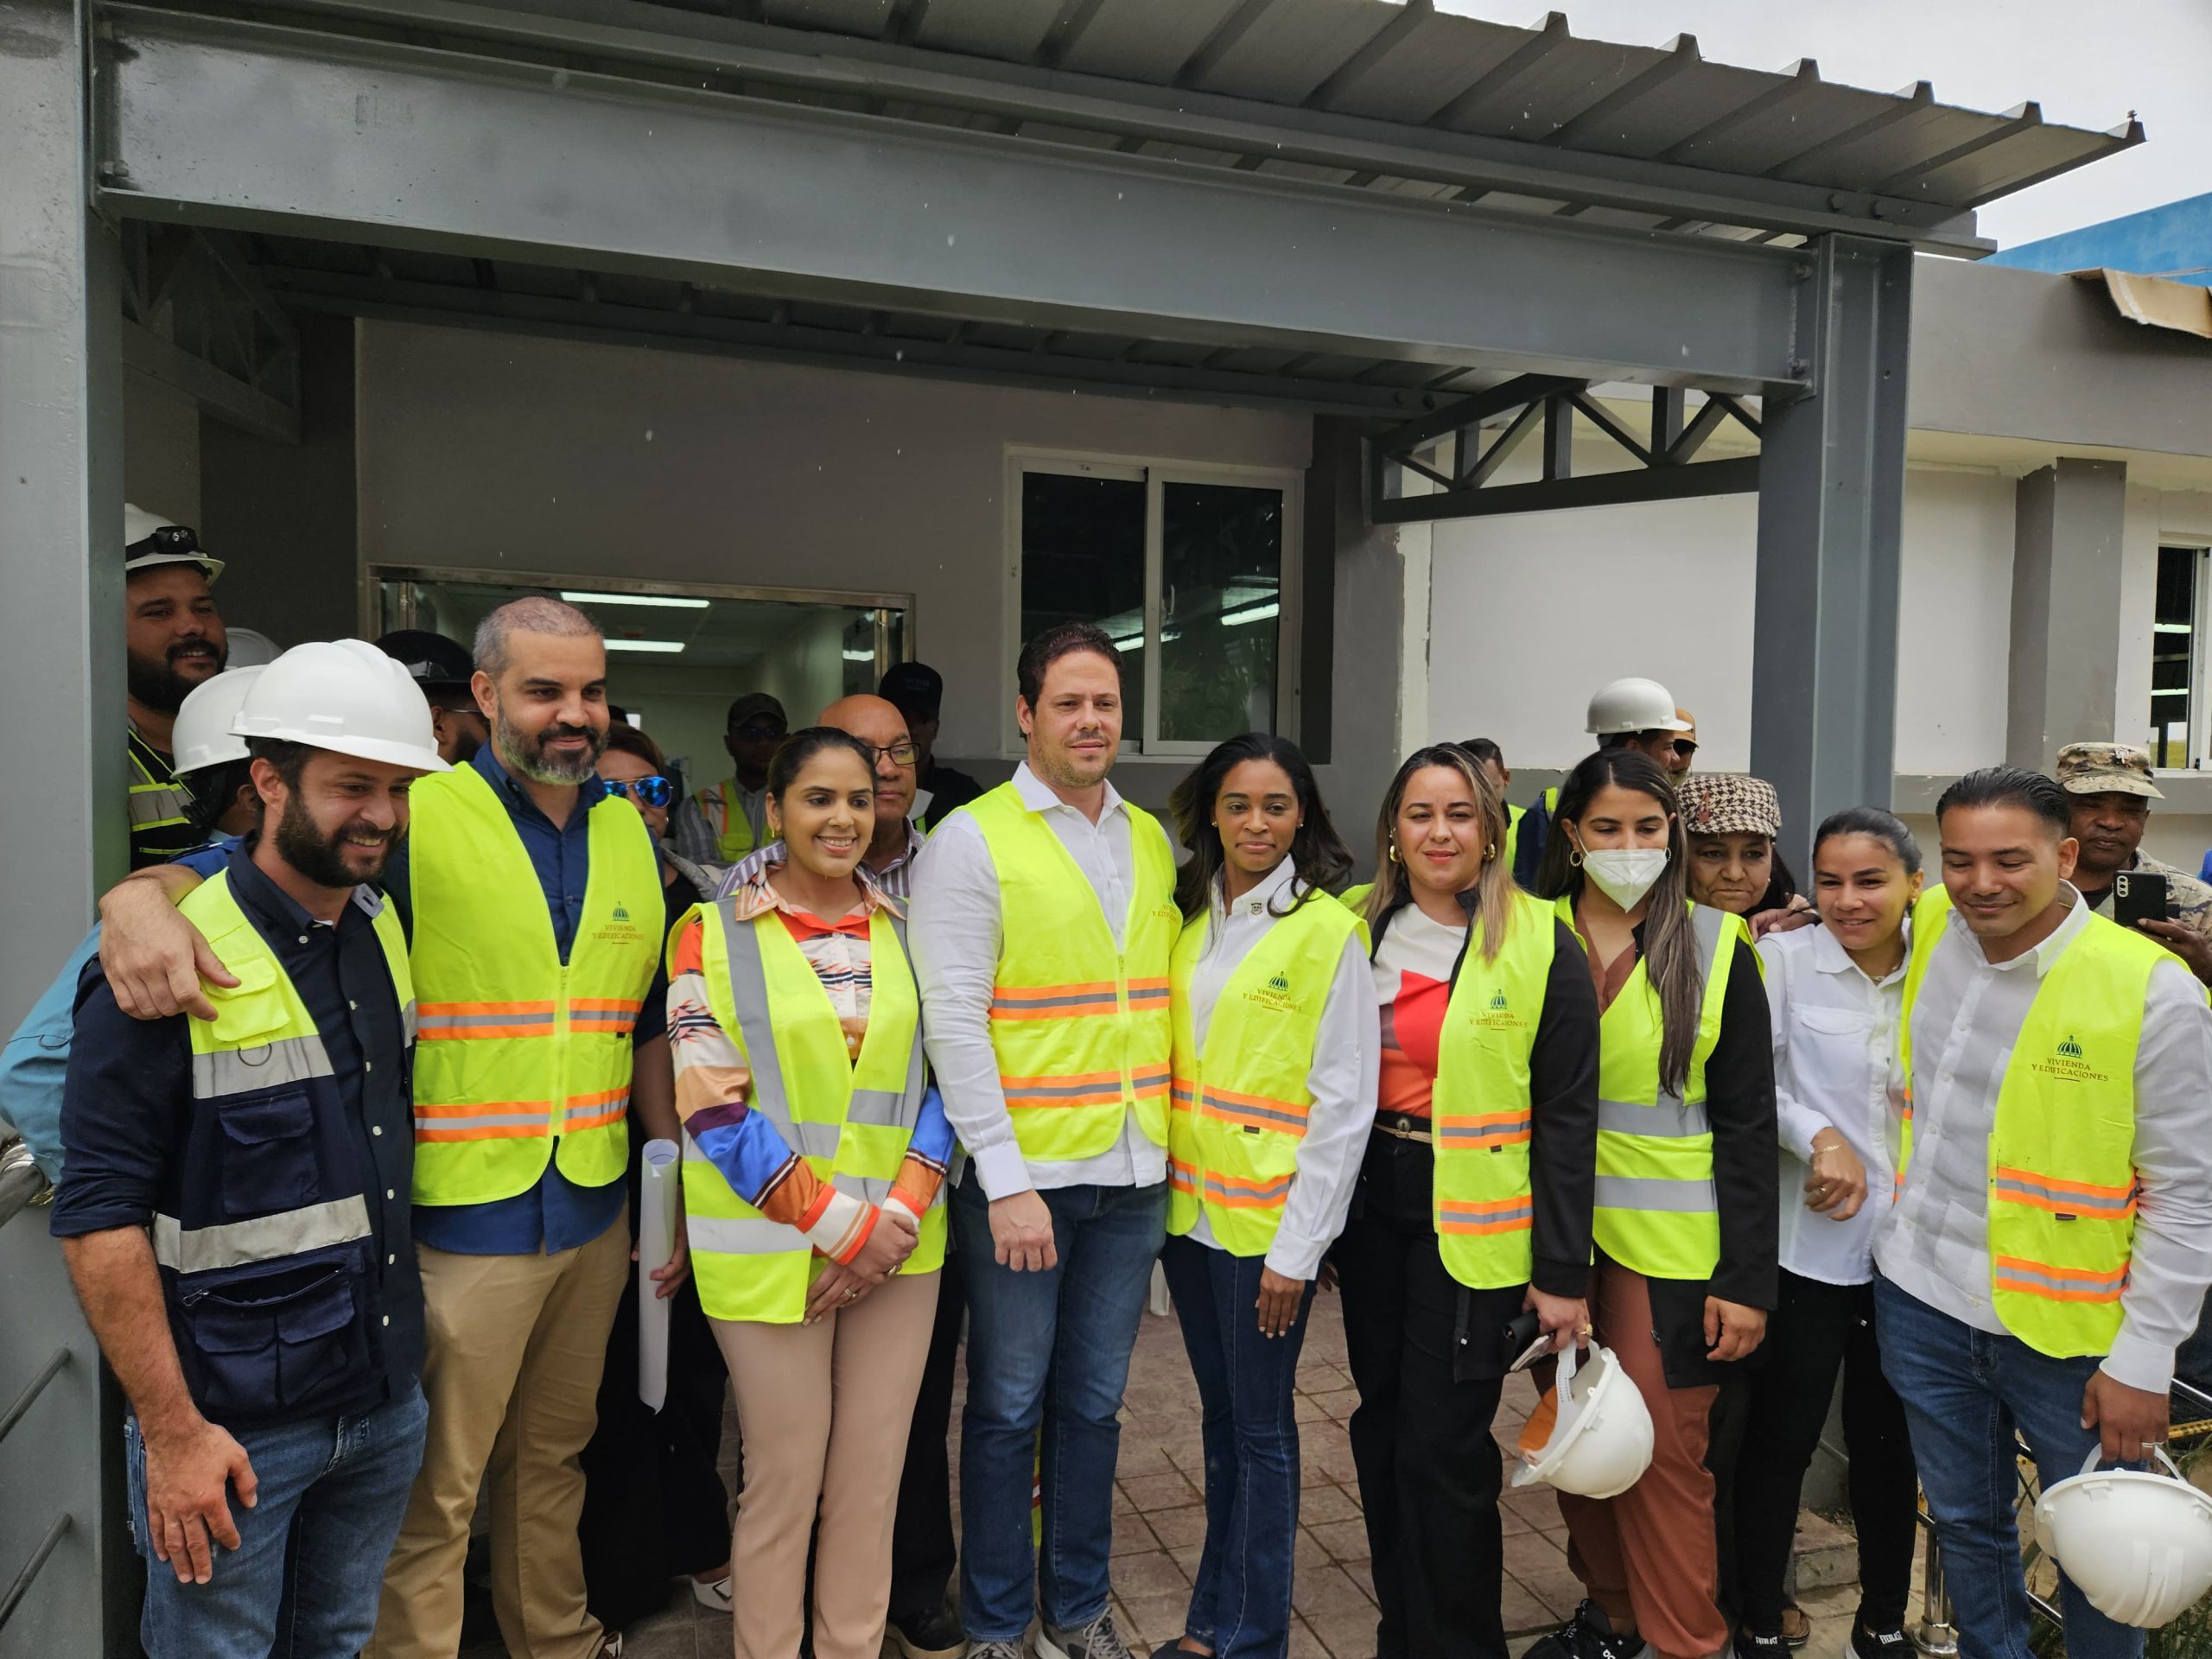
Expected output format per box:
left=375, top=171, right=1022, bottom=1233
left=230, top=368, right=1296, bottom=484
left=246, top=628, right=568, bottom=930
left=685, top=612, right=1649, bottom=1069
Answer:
left=956, top=783, right=1184, bottom=1164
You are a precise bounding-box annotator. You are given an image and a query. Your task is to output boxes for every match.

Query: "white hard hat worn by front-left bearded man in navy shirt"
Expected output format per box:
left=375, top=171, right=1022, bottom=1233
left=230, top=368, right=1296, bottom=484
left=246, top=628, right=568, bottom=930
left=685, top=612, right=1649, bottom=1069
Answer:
left=230, top=639, right=451, bottom=772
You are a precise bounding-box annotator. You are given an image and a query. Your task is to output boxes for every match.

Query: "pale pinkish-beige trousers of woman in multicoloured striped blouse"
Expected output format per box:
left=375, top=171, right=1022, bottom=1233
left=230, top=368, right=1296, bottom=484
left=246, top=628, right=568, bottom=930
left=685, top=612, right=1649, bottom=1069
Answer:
left=715, top=1274, right=938, bottom=1659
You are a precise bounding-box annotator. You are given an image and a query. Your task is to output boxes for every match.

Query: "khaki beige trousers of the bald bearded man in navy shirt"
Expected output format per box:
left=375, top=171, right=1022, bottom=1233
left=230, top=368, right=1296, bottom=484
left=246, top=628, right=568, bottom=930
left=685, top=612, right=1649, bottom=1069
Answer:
left=367, top=1219, right=631, bottom=1659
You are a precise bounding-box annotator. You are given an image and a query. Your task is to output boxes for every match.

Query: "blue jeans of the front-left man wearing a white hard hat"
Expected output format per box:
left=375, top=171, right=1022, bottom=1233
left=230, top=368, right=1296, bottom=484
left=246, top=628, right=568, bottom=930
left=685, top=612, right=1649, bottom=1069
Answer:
left=124, top=1387, right=429, bottom=1659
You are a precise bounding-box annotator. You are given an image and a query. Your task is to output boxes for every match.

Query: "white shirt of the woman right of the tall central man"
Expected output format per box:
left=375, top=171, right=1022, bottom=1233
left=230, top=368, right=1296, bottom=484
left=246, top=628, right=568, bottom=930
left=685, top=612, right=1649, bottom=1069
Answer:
left=1190, top=858, right=1382, bottom=1279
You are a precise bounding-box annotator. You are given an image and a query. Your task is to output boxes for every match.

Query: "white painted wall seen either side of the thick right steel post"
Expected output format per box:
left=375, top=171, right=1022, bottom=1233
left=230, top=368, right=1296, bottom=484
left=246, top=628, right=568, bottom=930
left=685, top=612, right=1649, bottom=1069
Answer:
left=1429, top=467, right=2025, bottom=772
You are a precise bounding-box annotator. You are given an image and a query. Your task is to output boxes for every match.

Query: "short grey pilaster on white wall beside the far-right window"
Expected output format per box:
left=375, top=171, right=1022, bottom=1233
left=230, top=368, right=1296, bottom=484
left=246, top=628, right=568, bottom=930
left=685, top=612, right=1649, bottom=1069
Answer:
left=1988, top=455, right=2148, bottom=772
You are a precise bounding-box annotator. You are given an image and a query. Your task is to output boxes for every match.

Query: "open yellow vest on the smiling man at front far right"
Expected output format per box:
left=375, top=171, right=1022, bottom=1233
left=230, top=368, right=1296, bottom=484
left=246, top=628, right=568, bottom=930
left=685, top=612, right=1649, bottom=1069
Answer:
left=1897, top=887, right=2172, bottom=1358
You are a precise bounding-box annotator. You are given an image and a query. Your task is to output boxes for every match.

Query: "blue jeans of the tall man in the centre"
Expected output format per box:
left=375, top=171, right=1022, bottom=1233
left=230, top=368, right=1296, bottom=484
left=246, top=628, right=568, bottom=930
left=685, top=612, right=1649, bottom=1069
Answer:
left=951, top=1173, right=1168, bottom=1642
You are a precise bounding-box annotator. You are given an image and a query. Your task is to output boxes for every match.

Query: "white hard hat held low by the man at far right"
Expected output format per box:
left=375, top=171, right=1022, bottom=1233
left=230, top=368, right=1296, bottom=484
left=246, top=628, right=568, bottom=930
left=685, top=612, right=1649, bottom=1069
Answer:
left=2035, top=1446, right=2212, bottom=1630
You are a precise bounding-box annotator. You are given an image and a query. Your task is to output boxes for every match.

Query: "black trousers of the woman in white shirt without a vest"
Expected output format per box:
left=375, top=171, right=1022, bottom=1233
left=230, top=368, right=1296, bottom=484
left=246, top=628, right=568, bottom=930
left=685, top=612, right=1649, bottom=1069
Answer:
left=1737, top=1269, right=1918, bottom=1635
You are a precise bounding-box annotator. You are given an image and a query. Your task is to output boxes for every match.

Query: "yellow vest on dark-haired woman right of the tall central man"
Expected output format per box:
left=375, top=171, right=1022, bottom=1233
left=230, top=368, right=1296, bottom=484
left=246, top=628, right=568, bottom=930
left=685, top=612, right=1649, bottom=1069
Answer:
left=1168, top=892, right=1367, bottom=1256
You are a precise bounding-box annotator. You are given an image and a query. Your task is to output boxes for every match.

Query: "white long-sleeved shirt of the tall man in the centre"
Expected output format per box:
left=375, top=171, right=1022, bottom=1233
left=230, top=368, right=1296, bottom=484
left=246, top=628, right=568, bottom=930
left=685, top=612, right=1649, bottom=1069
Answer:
left=907, top=761, right=1168, bottom=1199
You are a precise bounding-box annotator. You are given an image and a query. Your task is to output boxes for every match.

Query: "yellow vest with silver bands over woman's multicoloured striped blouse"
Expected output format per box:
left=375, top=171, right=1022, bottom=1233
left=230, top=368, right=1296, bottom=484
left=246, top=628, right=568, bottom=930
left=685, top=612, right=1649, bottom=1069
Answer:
left=671, top=898, right=944, bottom=1325
